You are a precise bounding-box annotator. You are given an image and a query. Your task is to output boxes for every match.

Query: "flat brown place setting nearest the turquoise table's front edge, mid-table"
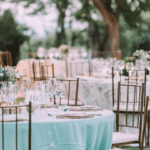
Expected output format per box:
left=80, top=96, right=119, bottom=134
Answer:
left=56, top=114, right=94, bottom=119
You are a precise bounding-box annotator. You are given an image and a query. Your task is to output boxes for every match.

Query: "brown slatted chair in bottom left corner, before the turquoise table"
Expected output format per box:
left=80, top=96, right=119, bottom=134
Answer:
left=0, top=102, right=32, bottom=150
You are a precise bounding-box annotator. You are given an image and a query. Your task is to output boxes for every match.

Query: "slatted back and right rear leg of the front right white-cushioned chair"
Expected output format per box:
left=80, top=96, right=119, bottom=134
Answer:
left=116, top=82, right=149, bottom=149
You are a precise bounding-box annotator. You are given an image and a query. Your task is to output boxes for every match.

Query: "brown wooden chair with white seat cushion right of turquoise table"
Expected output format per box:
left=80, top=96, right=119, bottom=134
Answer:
left=112, top=82, right=149, bottom=150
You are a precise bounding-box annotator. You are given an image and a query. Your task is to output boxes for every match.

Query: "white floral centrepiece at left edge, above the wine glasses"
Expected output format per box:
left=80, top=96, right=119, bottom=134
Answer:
left=0, top=66, right=21, bottom=83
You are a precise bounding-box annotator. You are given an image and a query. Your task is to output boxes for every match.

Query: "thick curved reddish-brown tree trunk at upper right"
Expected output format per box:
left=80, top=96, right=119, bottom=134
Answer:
left=92, top=0, right=119, bottom=58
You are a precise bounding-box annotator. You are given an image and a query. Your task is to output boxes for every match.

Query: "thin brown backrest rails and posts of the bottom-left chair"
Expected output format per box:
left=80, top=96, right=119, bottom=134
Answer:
left=0, top=102, right=32, bottom=150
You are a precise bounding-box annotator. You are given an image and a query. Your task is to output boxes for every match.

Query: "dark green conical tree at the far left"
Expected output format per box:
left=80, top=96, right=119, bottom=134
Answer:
left=0, top=10, right=29, bottom=65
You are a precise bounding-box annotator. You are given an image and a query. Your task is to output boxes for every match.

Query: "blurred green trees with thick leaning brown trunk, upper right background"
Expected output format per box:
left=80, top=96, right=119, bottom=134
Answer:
left=0, top=0, right=150, bottom=57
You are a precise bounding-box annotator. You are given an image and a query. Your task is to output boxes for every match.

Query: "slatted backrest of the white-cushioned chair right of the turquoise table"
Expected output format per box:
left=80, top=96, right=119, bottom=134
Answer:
left=116, top=82, right=145, bottom=131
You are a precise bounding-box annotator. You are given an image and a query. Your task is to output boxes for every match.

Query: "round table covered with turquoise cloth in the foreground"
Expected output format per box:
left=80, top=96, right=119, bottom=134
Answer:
left=0, top=109, right=114, bottom=150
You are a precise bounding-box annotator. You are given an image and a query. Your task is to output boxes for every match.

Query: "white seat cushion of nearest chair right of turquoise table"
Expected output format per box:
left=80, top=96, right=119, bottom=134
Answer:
left=112, top=132, right=139, bottom=144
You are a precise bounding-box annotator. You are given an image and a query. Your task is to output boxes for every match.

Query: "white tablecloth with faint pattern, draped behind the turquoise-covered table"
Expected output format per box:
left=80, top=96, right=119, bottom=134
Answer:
left=79, top=77, right=150, bottom=110
